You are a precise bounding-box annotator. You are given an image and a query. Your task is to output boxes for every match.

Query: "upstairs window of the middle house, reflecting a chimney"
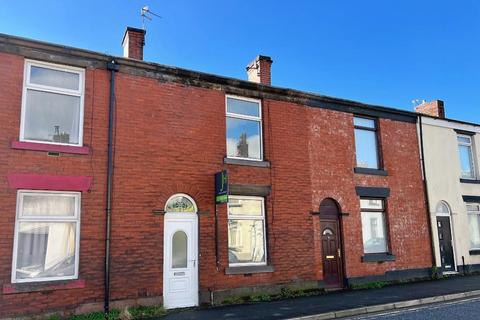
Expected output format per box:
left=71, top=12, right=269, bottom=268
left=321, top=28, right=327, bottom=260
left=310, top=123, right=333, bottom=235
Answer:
left=227, top=96, right=263, bottom=160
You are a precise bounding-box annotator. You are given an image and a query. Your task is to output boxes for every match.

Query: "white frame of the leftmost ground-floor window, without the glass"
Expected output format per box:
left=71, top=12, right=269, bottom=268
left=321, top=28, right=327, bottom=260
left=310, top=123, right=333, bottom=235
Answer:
left=11, top=190, right=81, bottom=283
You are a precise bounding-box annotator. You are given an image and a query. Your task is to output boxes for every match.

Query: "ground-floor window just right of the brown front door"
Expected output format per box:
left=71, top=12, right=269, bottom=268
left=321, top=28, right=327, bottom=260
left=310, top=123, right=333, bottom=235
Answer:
left=360, top=198, right=388, bottom=253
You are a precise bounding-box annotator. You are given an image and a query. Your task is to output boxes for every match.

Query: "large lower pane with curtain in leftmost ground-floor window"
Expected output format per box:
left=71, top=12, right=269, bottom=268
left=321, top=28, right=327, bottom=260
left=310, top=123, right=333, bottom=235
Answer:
left=16, top=222, right=76, bottom=279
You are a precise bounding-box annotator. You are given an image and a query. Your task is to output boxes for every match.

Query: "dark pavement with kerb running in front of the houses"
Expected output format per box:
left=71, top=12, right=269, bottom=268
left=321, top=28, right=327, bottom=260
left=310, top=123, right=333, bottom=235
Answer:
left=158, top=275, right=480, bottom=320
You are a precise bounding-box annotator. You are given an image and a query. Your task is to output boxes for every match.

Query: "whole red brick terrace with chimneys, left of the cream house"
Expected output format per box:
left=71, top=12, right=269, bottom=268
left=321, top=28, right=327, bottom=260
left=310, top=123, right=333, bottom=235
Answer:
left=0, top=28, right=432, bottom=317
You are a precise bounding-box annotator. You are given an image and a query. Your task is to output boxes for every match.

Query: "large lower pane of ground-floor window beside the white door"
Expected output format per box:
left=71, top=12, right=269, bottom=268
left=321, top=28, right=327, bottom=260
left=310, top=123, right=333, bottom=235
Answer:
left=228, top=219, right=265, bottom=263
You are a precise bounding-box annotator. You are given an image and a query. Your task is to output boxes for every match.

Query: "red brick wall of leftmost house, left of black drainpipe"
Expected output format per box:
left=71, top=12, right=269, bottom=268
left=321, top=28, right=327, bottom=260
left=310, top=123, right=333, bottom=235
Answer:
left=0, top=53, right=108, bottom=317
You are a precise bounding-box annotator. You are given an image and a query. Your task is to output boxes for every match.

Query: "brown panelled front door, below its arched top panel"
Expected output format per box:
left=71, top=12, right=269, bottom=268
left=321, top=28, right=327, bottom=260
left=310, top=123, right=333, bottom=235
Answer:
left=320, top=220, right=343, bottom=288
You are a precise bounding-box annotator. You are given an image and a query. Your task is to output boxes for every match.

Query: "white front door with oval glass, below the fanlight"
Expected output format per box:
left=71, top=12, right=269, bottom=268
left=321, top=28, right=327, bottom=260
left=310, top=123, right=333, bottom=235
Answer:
left=163, top=213, right=198, bottom=309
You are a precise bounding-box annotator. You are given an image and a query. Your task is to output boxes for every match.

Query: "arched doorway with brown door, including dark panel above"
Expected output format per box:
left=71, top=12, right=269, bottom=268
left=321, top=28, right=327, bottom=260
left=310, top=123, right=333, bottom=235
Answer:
left=320, top=198, right=343, bottom=288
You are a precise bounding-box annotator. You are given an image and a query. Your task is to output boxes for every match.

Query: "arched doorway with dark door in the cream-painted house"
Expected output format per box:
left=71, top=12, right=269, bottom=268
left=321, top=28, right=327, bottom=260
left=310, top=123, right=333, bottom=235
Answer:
left=436, top=201, right=456, bottom=272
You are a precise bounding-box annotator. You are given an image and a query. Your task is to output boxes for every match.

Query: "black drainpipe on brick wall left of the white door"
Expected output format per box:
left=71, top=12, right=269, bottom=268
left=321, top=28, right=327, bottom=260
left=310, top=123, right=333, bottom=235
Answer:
left=104, top=59, right=118, bottom=314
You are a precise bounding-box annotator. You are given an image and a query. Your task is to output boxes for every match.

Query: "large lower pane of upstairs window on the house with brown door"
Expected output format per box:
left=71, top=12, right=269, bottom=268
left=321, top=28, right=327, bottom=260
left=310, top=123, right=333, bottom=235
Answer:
left=355, top=129, right=378, bottom=169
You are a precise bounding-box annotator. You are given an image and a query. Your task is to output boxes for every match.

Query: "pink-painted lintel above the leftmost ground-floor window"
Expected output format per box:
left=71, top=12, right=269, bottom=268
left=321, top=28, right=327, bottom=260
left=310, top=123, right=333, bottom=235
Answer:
left=7, top=173, right=93, bottom=191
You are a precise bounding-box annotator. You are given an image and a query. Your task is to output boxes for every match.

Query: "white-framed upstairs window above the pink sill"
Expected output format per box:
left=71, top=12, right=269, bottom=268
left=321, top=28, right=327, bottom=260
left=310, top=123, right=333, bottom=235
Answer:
left=20, top=60, right=84, bottom=146
